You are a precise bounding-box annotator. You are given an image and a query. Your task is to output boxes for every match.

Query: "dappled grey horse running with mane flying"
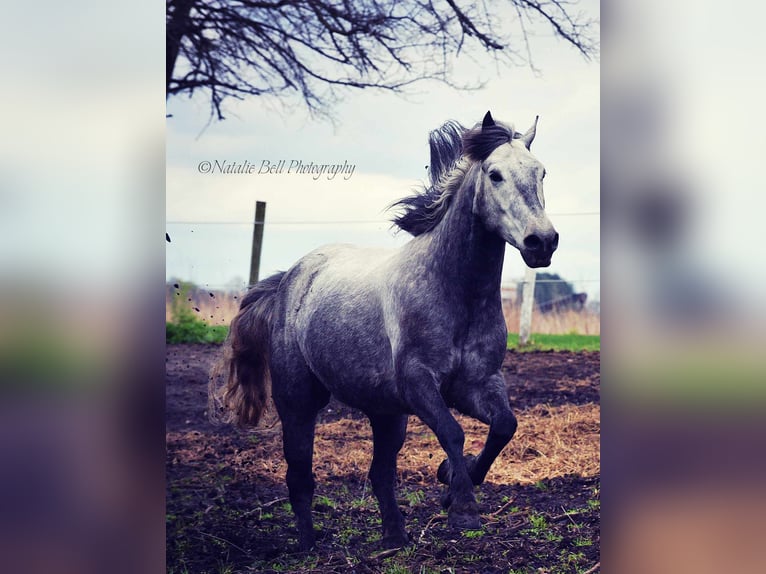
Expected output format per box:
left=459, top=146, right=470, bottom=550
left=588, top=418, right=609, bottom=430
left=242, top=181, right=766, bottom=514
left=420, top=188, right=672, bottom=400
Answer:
left=210, top=112, right=558, bottom=550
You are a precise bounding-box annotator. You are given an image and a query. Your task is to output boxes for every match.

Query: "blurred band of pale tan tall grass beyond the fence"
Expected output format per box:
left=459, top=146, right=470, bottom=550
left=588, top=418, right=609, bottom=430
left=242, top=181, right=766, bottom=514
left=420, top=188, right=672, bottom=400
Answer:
left=165, top=292, right=601, bottom=335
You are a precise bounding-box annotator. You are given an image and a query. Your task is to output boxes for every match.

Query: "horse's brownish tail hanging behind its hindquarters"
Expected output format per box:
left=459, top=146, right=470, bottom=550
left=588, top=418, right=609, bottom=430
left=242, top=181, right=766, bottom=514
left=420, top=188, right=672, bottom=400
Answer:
left=208, top=272, right=285, bottom=426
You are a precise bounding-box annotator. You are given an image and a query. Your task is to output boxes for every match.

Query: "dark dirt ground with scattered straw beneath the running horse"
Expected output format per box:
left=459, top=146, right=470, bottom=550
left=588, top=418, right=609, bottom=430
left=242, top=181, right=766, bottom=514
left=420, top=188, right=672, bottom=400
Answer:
left=166, top=345, right=600, bottom=574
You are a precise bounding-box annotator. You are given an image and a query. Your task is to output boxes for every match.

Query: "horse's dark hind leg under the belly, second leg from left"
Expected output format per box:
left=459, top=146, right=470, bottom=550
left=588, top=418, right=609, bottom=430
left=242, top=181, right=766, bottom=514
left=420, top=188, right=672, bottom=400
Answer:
left=370, top=415, right=409, bottom=548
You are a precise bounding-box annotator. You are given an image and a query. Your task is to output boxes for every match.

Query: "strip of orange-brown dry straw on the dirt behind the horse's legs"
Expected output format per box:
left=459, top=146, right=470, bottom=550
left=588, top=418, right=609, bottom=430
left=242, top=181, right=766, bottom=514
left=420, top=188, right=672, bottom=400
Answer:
left=231, top=404, right=600, bottom=485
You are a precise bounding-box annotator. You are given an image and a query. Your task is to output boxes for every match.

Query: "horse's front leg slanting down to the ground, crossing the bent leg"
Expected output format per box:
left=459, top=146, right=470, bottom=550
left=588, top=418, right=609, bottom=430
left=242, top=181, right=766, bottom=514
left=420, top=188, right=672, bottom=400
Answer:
left=403, top=366, right=481, bottom=530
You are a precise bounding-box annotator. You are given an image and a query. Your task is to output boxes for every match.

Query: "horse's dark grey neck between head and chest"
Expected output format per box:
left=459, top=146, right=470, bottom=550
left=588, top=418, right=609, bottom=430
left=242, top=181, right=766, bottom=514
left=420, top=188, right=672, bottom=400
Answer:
left=429, top=173, right=505, bottom=300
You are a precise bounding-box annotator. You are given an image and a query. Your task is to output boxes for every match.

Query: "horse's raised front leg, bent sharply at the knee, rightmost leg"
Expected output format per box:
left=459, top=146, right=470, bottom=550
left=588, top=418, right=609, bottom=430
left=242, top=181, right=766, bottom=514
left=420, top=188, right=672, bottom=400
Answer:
left=437, top=373, right=517, bottom=485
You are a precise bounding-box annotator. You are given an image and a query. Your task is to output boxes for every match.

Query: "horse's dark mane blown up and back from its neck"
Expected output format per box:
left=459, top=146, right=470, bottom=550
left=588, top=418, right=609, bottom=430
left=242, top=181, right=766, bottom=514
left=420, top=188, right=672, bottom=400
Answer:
left=391, top=120, right=520, bottom=236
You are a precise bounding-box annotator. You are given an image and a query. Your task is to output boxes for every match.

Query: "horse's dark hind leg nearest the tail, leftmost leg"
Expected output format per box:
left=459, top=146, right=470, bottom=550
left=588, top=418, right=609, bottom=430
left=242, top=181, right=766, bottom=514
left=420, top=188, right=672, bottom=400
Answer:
left=272, top=369, right=329, bottom=551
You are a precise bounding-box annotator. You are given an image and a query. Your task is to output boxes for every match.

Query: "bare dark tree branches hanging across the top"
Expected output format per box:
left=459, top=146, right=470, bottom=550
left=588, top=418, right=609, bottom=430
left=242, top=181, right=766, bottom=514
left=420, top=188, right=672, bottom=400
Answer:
left=166, top=0, right=598, bottom=119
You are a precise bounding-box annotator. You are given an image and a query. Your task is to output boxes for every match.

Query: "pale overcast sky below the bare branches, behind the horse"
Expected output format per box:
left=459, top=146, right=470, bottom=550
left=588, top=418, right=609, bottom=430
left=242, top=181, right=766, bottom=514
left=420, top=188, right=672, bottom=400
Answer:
left=166, top=1, right=600, bottom=299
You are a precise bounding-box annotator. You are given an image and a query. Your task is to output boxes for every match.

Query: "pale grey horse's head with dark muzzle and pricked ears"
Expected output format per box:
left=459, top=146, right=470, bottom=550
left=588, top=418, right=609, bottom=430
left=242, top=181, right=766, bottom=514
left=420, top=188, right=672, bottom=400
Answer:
left=463, top=112, right=559, bottom=267
